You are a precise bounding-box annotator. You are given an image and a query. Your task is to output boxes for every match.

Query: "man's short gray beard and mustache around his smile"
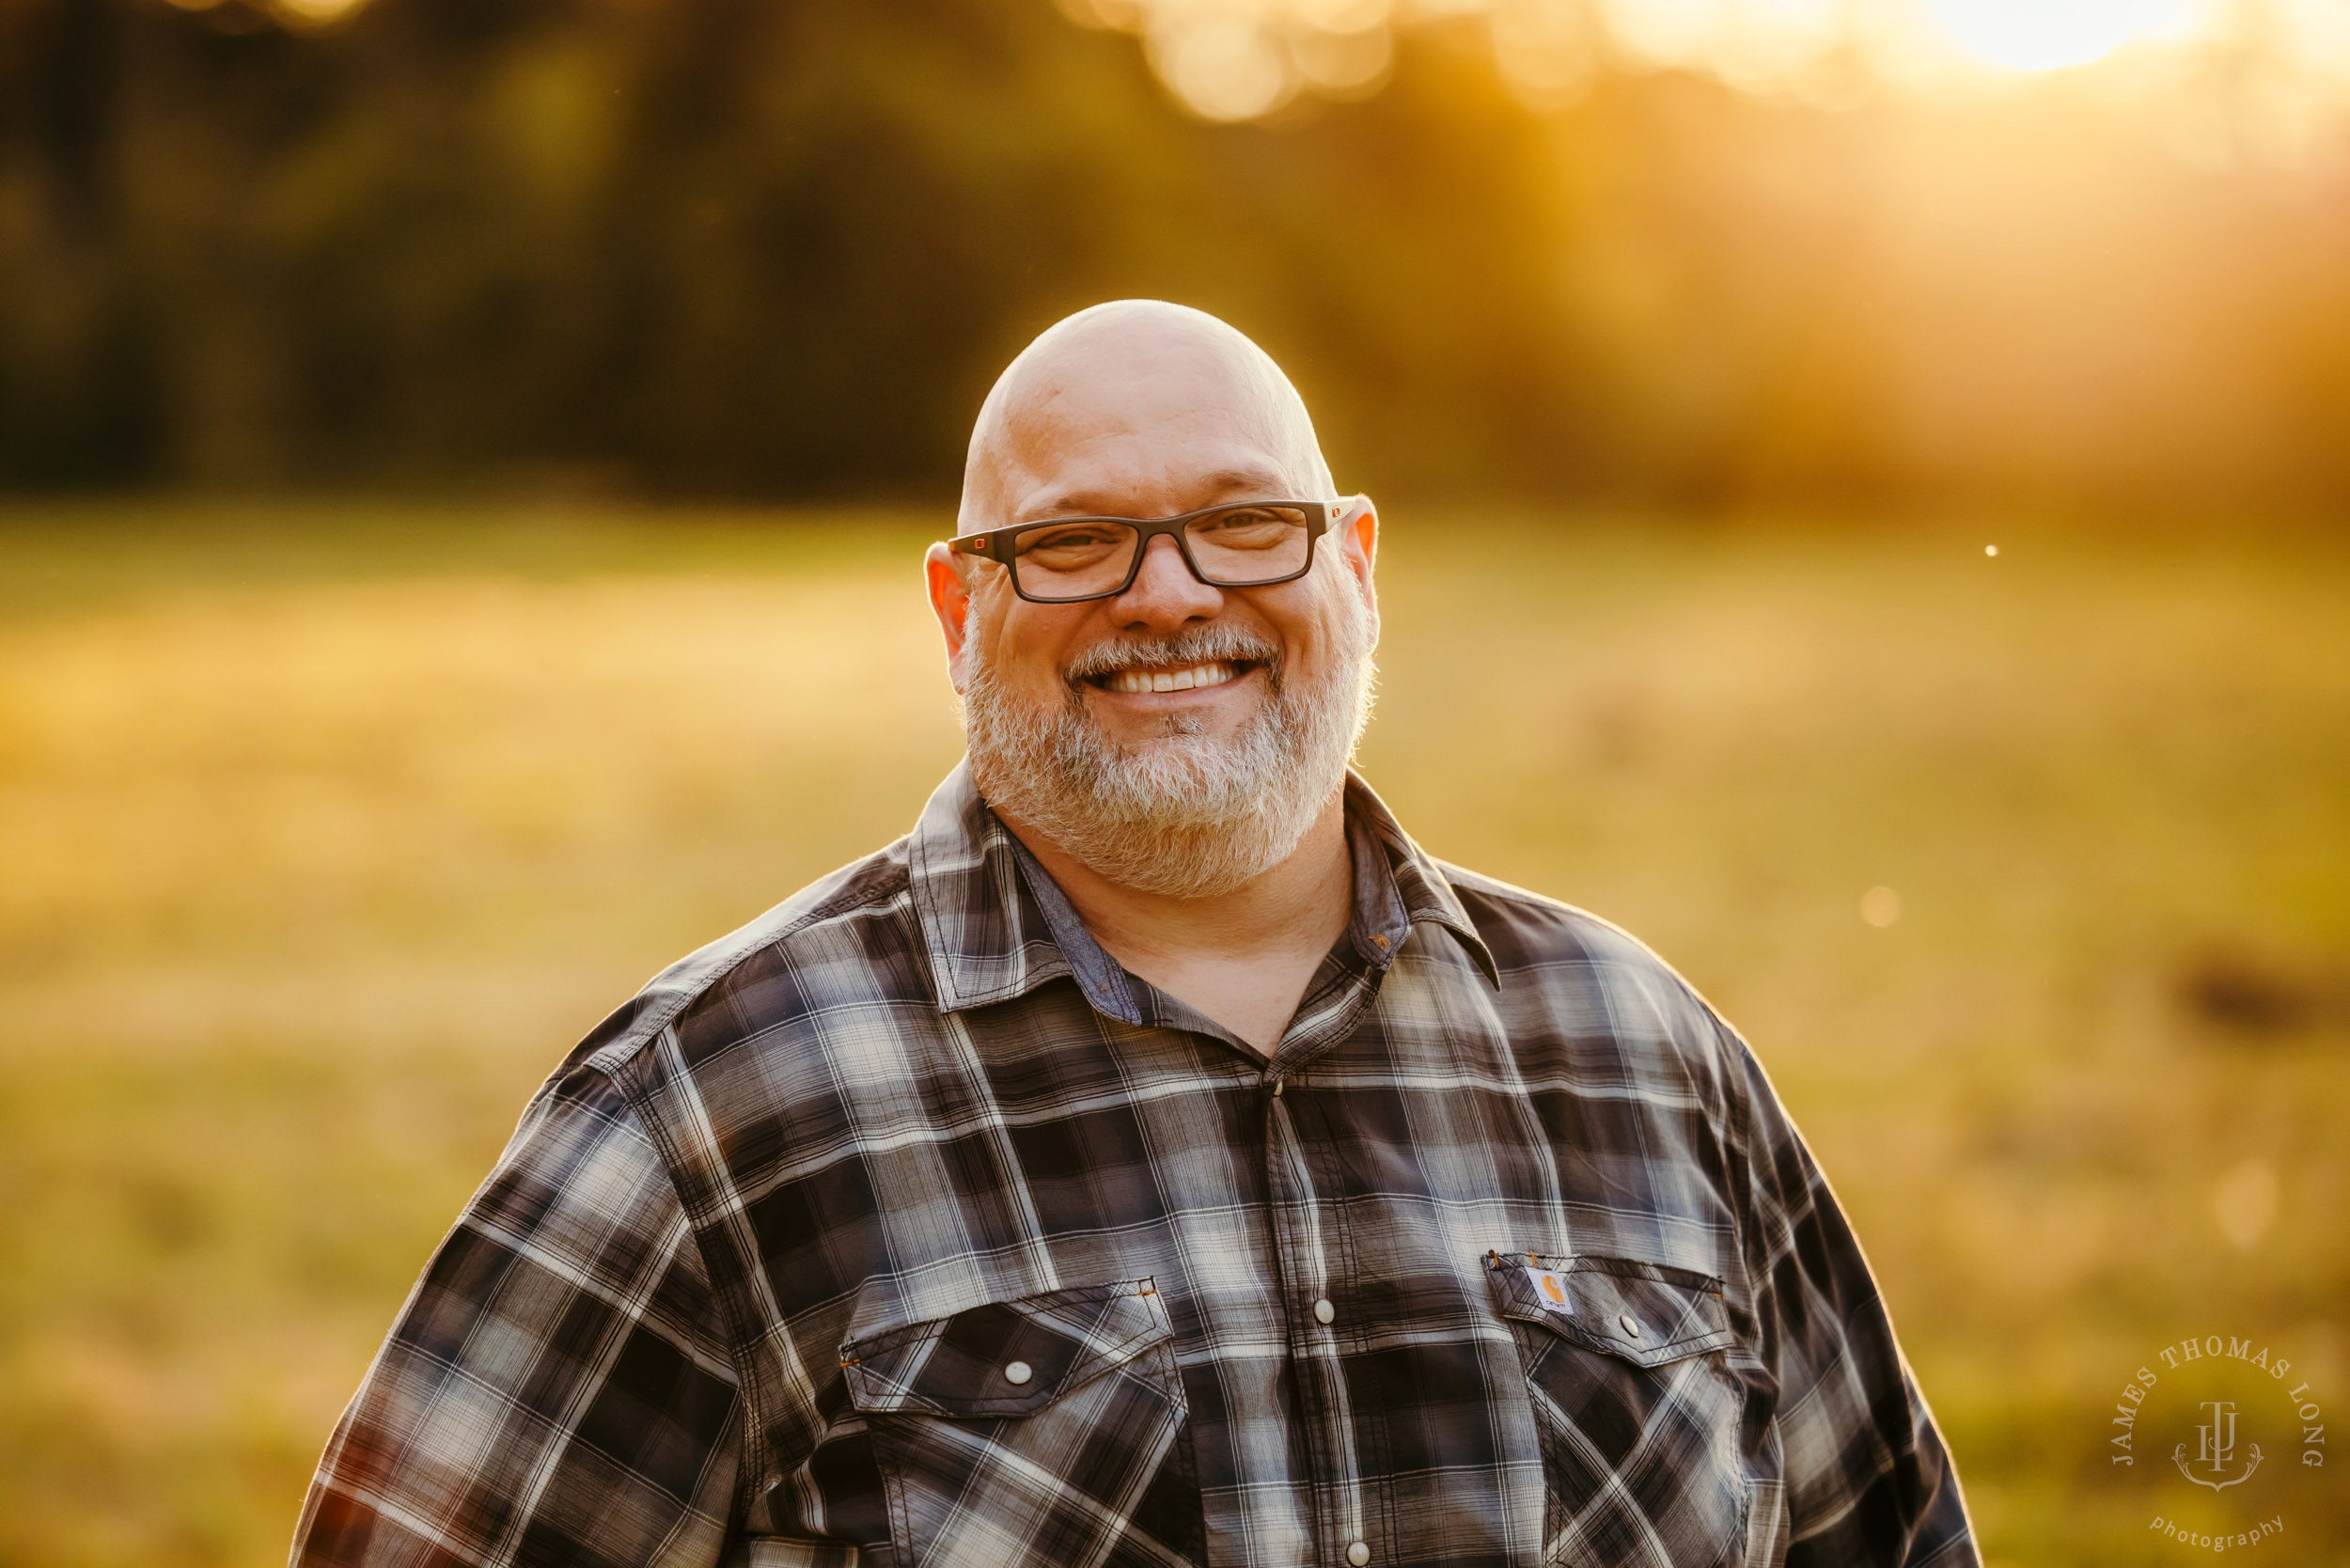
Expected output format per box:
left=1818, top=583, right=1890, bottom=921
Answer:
left=964, top=606, right=1372, bottom=898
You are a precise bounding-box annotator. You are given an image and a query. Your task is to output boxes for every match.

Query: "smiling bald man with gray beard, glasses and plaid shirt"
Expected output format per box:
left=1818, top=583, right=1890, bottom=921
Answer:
left=294, top=301, right=1977, bottom=1568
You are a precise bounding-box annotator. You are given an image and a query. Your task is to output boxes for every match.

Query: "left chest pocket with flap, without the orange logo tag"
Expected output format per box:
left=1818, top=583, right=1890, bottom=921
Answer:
left=841, top=1278, right=1203, bottom=1568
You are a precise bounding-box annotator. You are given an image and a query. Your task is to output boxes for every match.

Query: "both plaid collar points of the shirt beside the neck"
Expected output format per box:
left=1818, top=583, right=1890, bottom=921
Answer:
left=907, top=761, right=1499, bottom=1025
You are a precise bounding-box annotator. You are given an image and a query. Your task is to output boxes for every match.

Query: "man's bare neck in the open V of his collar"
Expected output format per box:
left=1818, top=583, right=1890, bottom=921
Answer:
left=996, top=792, right=1354, bottom=1056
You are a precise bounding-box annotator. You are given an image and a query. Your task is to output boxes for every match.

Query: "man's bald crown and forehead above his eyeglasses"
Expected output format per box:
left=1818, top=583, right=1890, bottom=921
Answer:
left=957, top=299, right=1333, bottom=534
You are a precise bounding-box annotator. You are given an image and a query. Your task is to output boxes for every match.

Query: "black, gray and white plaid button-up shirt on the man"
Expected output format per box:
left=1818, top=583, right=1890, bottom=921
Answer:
left=294, top=769, right=1977, bottom=1568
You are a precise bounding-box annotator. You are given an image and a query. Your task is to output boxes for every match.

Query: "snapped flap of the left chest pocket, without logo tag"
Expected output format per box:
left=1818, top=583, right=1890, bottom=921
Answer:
left=841, top=1278, right=1175, bottom=1418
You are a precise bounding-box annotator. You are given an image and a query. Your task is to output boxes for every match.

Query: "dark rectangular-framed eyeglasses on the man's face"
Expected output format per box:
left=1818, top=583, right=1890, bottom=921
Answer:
left=949, top=501, right=1356, bottom=604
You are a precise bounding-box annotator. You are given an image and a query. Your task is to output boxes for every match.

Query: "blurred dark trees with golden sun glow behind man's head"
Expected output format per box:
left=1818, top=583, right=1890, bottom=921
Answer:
left=0, top=0, right=2350, bottom=506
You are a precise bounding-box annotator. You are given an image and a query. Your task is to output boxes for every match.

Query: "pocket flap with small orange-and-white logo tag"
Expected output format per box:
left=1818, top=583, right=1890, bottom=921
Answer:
left=1485, top=1253, right=1737, bottom=1366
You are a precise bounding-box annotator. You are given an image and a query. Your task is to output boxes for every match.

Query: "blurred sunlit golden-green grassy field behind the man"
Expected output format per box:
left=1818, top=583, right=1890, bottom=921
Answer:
left=0, top=506, right=2350, bottom=1568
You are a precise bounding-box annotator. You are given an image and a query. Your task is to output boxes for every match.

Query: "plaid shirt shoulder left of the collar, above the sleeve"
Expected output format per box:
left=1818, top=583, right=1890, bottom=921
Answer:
left=555, top=839, right=924, bottom=1081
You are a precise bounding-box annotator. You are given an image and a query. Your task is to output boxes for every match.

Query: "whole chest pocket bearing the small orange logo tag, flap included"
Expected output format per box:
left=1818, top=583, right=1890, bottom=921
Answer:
left=1485, top=1253, right=1751, bottom=1568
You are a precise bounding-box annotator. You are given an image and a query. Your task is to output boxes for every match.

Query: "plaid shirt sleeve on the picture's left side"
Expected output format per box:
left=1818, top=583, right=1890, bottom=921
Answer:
left=291, top=1067, right=743, bottom=1568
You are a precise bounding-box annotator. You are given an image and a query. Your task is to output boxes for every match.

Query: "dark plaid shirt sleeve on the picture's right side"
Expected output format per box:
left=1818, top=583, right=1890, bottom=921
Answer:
left=1725, top=1029, right=1982, bottom=1568
